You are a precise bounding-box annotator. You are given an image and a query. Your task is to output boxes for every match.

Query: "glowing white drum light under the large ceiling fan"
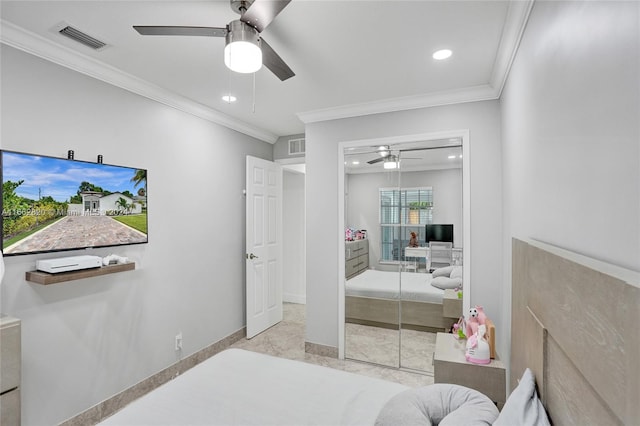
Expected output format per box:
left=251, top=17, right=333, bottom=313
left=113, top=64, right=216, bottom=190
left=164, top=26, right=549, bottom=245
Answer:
left=224, top=20, right=262, bottom=74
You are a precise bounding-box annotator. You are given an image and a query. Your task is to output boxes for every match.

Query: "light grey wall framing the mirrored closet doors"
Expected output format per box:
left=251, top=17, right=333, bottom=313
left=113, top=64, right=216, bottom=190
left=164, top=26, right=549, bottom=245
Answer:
left=305, top=101, right=508, bottom=350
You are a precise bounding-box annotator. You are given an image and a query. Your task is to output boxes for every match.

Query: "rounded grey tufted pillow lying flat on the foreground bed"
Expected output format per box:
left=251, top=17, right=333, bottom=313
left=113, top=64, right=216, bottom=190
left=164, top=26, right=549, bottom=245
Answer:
left=375, top=383, right=498, bottom=426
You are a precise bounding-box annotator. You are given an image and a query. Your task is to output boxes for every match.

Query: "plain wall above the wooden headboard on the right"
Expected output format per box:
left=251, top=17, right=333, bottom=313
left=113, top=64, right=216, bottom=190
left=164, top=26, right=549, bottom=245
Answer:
left=501, top=1, right=640, bottom=372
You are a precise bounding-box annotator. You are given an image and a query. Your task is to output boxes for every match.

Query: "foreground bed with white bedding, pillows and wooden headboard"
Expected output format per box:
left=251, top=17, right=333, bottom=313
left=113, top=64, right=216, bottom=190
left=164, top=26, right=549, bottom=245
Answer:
left=96, top=240, right=640, bottom=426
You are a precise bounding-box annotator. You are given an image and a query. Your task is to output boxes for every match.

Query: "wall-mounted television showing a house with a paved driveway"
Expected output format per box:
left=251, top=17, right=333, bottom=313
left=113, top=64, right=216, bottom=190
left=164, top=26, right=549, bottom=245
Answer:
left=0, top=150, right=148, bottom=256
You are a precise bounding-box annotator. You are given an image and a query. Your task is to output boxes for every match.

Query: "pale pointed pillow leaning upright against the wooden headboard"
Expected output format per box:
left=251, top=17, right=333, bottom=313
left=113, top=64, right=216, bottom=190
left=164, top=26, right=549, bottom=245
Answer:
left=494, top=368, right=549, bottom=426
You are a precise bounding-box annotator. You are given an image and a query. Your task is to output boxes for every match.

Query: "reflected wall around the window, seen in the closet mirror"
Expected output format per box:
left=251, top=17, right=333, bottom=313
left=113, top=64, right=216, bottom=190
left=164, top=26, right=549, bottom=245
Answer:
left=345, top=169, right=462, bottom=268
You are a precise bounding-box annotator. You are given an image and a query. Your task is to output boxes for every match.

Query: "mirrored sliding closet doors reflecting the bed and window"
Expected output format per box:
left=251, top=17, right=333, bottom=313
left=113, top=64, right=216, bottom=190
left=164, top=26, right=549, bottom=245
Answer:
left=345, top=141, right=463, bottom=373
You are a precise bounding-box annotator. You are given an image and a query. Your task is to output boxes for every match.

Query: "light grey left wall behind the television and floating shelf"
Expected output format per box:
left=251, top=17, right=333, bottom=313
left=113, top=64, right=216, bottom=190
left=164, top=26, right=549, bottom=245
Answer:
left=0, top=45, right=272, bottom=425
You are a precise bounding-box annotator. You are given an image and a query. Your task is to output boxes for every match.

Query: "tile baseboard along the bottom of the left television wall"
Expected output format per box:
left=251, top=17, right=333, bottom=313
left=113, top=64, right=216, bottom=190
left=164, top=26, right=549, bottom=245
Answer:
left=60, top=327, right=247, bottom=426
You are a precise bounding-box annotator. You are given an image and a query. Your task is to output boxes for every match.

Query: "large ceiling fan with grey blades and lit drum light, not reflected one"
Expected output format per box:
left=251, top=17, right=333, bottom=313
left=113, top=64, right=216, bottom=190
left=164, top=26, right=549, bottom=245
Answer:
left=133, top=0, right=295, bottom=81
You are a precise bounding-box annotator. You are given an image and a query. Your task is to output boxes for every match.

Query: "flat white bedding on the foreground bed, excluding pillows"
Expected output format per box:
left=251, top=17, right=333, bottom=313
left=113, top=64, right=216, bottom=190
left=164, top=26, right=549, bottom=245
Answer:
left=100, top=349, right=408, bottom=425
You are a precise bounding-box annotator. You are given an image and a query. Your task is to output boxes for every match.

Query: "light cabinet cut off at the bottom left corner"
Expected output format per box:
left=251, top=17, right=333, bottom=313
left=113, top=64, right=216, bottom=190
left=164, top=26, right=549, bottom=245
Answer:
left=0, top=316, right=22, bottom=426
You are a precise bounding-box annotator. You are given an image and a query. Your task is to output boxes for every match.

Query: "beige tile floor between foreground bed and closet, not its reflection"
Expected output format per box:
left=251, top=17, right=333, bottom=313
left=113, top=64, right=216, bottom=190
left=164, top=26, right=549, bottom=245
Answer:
left=232, top=303, right=433, bottom=387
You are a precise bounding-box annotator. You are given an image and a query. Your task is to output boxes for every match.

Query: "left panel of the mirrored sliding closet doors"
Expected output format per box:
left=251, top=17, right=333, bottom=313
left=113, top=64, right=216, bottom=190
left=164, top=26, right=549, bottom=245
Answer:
left=345, top=151, right=400, bottom=367
